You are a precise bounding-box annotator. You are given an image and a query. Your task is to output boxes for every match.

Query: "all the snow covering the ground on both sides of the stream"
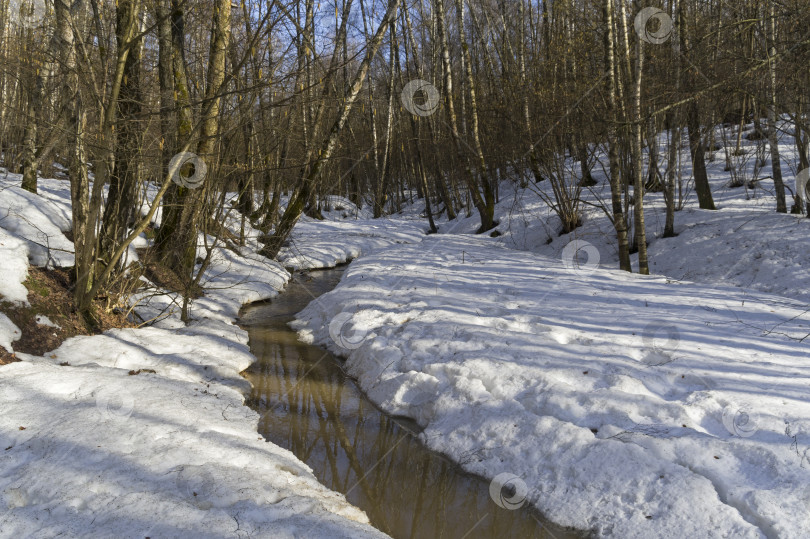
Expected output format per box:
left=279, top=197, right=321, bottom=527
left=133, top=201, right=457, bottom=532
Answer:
left=0, top=116, right=810, bottom=537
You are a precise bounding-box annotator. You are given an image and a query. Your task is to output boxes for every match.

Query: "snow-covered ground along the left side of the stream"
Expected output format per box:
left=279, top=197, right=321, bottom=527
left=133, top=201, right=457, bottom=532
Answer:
left=0, top=175, right=419, bottom=538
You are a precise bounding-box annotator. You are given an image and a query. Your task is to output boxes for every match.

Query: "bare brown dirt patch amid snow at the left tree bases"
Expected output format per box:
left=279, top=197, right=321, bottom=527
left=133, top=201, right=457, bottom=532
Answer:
left=0, top=267, right=135, bottom=358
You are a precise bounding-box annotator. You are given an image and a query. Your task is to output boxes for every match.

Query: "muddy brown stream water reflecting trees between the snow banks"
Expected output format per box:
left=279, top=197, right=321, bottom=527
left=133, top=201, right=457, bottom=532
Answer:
left=241, top=269, right=577, bottom=539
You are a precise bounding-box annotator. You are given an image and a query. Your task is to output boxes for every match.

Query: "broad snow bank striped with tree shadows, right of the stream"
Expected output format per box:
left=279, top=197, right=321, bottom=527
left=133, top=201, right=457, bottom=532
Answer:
left=295, top=235, right=810, bottom=538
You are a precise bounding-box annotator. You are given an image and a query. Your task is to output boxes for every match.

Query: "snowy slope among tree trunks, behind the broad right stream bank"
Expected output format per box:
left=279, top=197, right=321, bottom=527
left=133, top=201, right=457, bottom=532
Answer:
left=430, top=117, right=810, bottom=303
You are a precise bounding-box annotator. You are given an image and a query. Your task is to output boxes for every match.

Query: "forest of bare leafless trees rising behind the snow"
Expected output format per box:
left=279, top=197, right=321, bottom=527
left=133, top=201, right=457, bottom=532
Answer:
left=0, top=0, right=810, bottom=320
